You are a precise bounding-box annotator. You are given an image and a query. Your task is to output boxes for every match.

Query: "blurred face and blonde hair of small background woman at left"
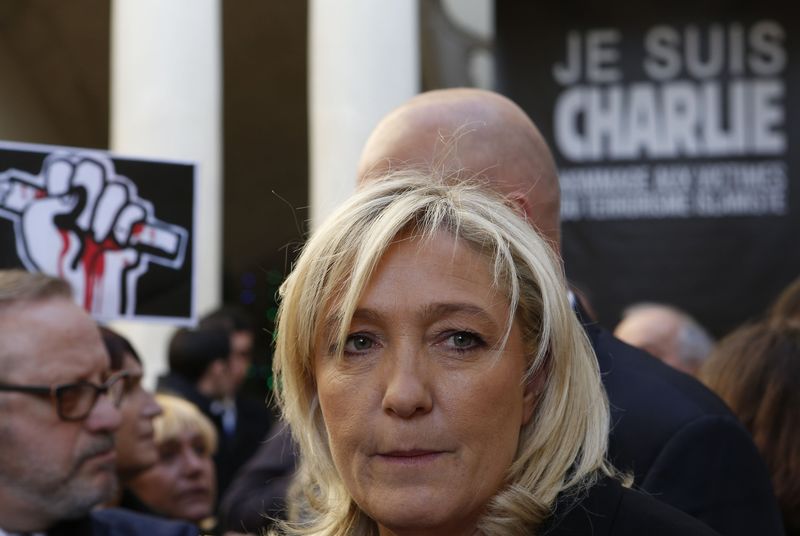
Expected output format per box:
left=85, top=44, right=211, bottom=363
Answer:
left=129, top=394, right=217, bottom=530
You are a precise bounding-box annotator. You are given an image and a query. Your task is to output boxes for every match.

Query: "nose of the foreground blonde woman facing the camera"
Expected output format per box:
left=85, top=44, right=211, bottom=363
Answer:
left=382, top=345, right=433, bottom=419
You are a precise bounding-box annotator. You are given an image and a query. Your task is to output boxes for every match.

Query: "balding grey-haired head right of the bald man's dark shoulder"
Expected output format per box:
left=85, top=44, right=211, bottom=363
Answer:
left=614, top=302, right=714, bottom=376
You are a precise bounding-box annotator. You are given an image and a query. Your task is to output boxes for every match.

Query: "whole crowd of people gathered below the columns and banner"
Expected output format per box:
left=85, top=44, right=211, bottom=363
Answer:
left=0, top=89, right=800, bottom=536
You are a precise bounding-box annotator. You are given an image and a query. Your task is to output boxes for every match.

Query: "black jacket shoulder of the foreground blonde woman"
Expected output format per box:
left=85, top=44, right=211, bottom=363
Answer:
left=539, top=478, right=717, bottom=536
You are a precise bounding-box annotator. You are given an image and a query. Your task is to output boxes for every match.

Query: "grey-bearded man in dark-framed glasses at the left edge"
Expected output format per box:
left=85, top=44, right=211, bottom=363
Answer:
left=0, top=270, right=197, bottom=536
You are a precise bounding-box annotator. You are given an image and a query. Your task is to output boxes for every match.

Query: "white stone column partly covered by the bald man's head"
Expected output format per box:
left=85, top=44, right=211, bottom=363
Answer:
left=308, top=0, right=420, bottom=225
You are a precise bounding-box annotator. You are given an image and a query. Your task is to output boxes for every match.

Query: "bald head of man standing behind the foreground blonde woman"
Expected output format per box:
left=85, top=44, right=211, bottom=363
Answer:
left=358, top=89, right=560, bottom=248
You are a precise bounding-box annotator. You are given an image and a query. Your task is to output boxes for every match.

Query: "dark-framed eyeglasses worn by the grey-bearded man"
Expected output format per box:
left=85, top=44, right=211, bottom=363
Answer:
left=0, top=371, right=130, bottom=421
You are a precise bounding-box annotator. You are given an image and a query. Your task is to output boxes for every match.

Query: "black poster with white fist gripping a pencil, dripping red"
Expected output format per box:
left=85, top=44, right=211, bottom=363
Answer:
left=0, top=143, right=196, bottom=324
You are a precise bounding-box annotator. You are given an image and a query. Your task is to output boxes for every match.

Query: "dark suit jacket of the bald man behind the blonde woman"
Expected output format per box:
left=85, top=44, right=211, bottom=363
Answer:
left=577, top=306, right=783, bottom=536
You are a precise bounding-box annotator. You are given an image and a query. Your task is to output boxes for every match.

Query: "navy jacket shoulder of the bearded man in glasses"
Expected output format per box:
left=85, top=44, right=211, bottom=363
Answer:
left=47, top=508, right=199, bottom=536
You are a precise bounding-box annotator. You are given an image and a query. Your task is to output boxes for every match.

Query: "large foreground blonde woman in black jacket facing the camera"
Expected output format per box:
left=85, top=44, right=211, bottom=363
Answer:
left=274, top=173, right=713, bottom=536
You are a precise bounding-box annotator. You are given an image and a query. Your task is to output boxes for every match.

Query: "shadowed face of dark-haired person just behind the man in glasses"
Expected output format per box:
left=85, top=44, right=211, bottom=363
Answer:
left=116, top=353, right=161, bottom=480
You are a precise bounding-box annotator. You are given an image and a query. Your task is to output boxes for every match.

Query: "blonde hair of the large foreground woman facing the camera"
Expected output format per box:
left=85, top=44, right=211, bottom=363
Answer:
left=273, top=172, right=610, bottom=536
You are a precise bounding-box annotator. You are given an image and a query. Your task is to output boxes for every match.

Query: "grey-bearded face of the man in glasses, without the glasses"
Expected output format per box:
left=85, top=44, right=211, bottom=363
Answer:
left=0, top=298, right=120, bottom=532
